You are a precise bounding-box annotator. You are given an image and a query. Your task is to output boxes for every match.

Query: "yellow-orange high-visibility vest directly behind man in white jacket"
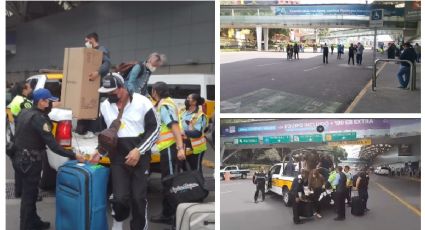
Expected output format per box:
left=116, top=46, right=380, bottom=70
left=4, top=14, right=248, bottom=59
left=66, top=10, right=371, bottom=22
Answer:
left=156, top=97, right=179, bottom=151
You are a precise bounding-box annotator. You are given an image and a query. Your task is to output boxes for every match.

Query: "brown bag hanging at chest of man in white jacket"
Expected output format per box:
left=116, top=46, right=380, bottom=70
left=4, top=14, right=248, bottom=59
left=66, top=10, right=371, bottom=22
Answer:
left=97, top=109, right=124, bottom=155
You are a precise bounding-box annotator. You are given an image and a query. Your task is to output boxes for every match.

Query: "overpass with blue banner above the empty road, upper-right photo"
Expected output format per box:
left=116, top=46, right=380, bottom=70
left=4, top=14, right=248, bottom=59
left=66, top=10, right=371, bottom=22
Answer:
left=220, top=4, right=420, bottom=51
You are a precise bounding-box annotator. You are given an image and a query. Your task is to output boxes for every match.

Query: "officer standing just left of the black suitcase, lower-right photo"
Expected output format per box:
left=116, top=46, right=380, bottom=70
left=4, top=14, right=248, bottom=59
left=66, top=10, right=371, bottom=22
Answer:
left=333, top=166, right=347, bottom=221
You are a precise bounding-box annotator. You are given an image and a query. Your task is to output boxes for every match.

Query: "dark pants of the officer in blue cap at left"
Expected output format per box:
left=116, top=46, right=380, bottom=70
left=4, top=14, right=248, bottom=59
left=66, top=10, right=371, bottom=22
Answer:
left=13, top=160, right=42, bottom=230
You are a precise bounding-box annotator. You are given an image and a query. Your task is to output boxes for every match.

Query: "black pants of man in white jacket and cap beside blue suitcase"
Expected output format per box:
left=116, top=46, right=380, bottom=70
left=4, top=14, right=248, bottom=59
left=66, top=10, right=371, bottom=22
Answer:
left=111, top=152, right=150, bottom=230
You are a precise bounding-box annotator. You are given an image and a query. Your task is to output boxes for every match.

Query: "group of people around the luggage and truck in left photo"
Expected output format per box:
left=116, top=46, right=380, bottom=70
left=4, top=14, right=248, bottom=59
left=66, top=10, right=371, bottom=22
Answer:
left=9, top=33, right=208, bottom=230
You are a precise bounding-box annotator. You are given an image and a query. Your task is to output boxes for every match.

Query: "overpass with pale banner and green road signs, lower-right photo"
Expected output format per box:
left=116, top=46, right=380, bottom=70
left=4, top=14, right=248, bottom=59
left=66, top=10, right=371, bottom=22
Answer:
left=220, top=119, right=421, bottom=164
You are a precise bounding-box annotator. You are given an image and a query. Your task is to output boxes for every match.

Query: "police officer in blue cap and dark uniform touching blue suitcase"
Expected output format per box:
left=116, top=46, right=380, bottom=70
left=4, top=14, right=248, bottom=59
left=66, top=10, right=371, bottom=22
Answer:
left=13, top=89, right=84, bottom=230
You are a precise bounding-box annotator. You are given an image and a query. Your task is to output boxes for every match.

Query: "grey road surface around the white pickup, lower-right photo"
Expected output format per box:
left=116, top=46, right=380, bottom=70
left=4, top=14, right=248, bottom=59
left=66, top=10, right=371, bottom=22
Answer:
left=220, top=176, right=421, bottom=230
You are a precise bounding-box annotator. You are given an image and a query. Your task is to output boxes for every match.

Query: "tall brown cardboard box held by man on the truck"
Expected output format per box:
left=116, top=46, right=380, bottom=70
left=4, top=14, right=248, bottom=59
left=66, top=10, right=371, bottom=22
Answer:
left=61, top=48, right=103, bottom=119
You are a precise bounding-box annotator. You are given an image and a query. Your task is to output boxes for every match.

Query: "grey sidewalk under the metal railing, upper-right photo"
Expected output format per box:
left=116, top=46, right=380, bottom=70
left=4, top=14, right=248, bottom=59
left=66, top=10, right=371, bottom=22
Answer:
left=345, top=63, right=421, bottom=113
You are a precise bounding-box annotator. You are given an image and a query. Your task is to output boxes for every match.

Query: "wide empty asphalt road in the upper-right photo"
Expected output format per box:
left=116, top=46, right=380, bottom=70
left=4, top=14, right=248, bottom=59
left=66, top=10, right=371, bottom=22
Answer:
left=220, top=50, right=379, bottom=113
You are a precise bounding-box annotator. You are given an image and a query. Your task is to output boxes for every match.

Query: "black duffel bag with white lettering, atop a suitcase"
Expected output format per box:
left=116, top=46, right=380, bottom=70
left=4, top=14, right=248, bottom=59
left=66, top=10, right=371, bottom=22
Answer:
left=162, top=161, right=209, bottom=210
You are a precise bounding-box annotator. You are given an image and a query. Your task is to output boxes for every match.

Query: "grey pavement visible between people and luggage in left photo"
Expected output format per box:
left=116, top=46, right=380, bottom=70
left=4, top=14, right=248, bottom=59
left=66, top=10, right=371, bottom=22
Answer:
left=6, top=137, right=215, bottom=230
